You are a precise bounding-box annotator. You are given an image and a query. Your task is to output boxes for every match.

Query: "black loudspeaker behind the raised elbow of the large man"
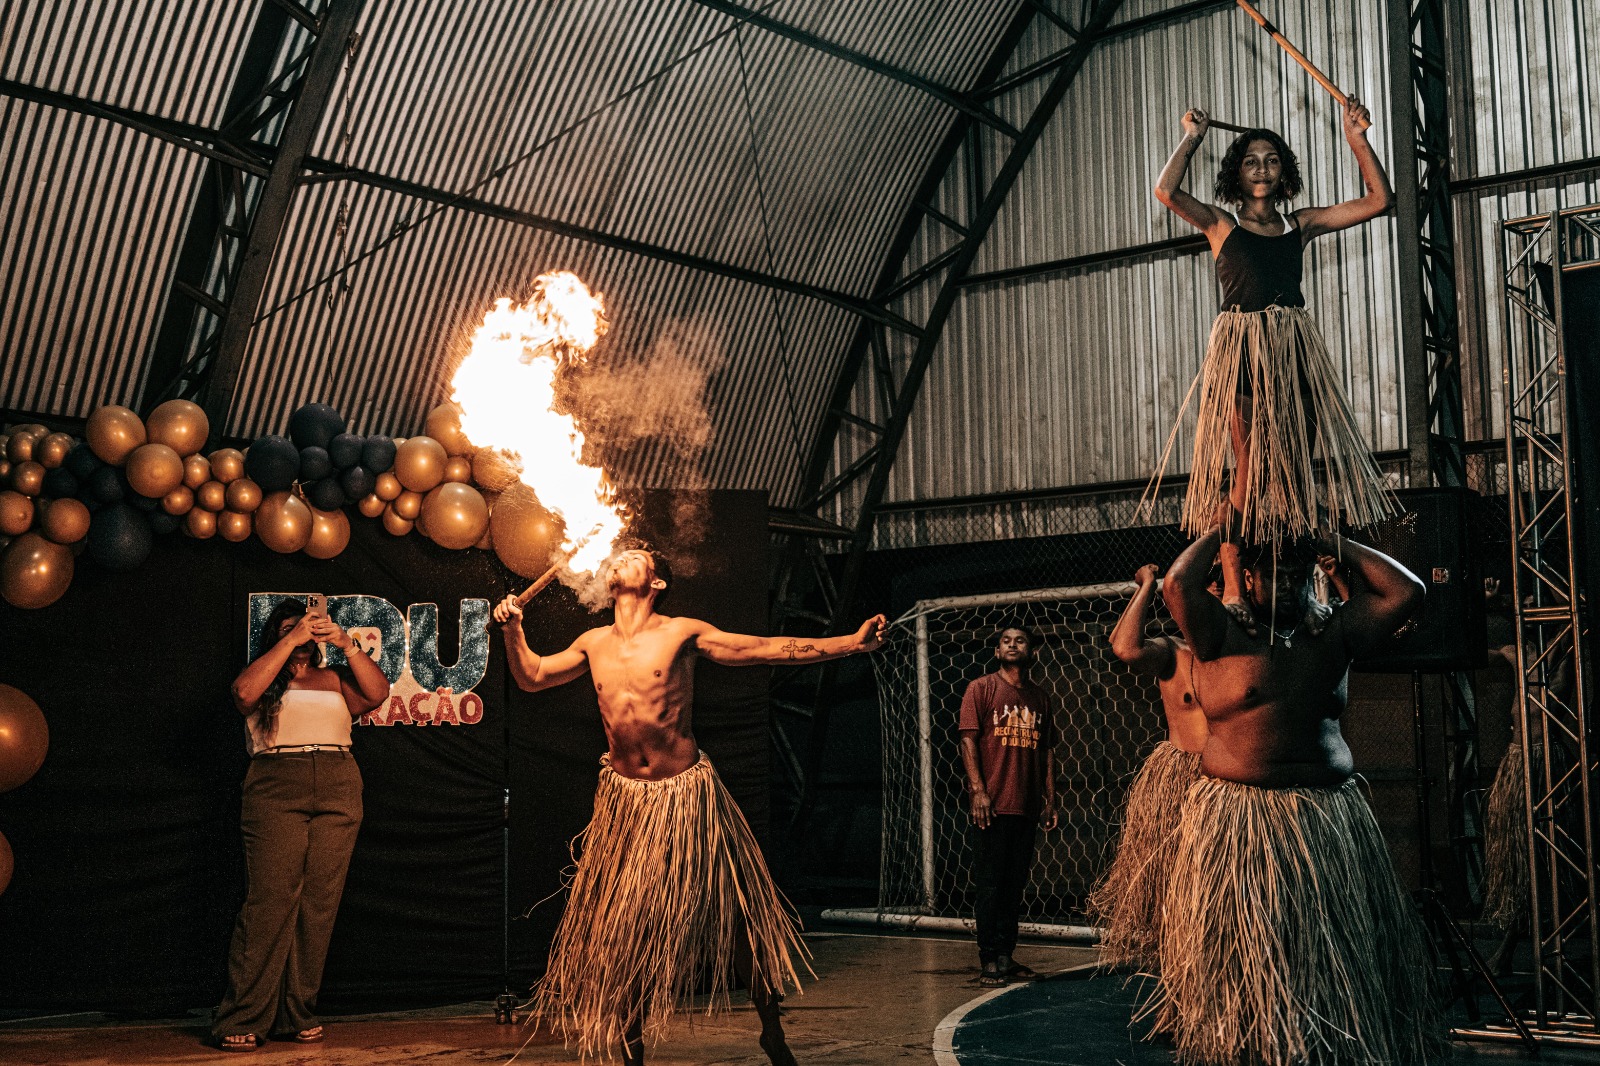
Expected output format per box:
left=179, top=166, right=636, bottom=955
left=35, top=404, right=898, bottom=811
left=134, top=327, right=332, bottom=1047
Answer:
left=1355, top=488, right=1488, bottom=674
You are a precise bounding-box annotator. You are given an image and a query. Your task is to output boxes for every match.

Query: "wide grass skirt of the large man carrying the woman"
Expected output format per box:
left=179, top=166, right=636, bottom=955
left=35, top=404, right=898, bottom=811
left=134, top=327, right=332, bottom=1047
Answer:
left=1152, top=778, right=1450, bottom=1066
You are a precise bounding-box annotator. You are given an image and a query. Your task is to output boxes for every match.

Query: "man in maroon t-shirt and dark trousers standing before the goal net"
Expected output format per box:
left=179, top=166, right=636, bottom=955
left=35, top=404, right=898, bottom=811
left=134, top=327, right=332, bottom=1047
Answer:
left=960, top=623, right=1056, bottom=986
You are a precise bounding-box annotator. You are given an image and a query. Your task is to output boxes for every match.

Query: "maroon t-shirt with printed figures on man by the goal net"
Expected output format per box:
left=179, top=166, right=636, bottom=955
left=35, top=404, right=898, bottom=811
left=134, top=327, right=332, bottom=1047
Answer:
left=960, top=671, right=1056, bottom=818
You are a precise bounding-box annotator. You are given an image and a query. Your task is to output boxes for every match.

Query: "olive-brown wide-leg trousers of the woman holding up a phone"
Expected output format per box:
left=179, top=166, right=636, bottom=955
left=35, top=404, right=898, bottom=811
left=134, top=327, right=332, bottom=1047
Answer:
left=211, top=751, right=362, bottom=1039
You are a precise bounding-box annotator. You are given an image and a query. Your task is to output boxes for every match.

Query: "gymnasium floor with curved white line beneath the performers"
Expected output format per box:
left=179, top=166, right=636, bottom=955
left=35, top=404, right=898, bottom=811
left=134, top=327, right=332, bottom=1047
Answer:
left=0, top=927, right=1600, bottom=1066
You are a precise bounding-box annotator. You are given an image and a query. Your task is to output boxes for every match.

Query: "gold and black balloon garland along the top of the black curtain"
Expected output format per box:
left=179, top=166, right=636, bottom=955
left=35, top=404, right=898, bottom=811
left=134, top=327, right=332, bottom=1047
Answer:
left=0, top=400, right=562, bottom=610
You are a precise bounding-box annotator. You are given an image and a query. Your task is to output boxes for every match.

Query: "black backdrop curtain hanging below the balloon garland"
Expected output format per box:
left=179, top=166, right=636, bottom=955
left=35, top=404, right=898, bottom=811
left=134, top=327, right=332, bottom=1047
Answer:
left=0, top=491, right=768, bottom=1013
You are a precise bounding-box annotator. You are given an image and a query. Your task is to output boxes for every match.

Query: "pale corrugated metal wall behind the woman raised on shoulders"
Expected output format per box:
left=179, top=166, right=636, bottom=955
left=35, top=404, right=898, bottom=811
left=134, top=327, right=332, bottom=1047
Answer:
left=835, top=0, right=1405, bottom=522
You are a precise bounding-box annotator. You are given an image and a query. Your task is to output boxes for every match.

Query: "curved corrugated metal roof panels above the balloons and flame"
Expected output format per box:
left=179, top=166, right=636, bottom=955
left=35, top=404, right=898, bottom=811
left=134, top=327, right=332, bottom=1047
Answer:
left=0, top=0, right=1019, bottom=501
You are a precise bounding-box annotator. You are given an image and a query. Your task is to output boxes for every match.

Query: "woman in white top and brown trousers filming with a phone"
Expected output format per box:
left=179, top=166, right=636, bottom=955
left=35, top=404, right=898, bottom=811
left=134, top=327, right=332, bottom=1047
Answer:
left=211, top=595, right=389, bottom=1052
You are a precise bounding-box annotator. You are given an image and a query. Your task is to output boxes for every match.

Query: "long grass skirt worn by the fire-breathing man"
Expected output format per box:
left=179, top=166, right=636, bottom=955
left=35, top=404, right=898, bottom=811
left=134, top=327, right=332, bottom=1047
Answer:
left=536, top=754, right=805, bottom=1058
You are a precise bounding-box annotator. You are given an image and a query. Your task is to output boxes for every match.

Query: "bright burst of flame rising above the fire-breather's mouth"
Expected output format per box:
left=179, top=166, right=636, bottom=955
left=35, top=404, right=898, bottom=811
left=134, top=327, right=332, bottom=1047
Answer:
left=450, top=271, right=627, bottom=573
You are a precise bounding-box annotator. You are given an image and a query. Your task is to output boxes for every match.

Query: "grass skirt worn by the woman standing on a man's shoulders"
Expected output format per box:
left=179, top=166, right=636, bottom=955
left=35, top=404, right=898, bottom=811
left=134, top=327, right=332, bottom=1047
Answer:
left=1162, top=306, right=1398, bottom=543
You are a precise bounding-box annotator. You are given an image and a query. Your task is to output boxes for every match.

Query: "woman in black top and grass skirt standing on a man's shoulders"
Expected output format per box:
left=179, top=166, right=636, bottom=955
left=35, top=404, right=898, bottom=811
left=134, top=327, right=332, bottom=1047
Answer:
left=1155, top=96, right=1397, bottom=631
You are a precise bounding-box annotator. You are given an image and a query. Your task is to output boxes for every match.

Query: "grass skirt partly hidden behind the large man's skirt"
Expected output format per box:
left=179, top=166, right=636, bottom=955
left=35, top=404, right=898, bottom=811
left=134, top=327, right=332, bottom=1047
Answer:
left=1090, top=741, right=1200, bottom=968
